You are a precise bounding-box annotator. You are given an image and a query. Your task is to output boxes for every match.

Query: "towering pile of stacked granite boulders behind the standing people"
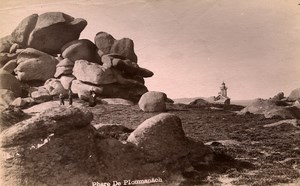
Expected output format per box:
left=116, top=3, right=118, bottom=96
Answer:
left=0, top=12, right=153, bottom=108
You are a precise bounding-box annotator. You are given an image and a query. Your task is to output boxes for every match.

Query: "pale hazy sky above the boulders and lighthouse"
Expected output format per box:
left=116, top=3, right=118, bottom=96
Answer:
left=0, top=0, right=300, bottom=100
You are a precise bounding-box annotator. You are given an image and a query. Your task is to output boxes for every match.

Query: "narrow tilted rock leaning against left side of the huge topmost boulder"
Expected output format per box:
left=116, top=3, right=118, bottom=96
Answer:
left=11, top=14, right=38, bottom=47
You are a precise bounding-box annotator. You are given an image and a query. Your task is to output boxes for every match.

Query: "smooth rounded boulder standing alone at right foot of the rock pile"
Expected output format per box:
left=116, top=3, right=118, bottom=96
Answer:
left=139, top=91, right=167, bottom=112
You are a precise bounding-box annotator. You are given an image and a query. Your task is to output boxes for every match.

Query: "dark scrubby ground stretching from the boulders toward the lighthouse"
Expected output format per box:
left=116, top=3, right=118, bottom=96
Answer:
left=2, top=100, right=300, bottom=185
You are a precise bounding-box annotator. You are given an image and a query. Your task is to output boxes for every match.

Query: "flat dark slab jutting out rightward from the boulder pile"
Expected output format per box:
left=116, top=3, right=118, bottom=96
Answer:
left=101, top=54, right=153, bottom=77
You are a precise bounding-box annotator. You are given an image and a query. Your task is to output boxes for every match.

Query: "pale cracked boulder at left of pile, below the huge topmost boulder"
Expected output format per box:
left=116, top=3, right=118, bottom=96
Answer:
left=15, top=48, right=58, bottom=81
